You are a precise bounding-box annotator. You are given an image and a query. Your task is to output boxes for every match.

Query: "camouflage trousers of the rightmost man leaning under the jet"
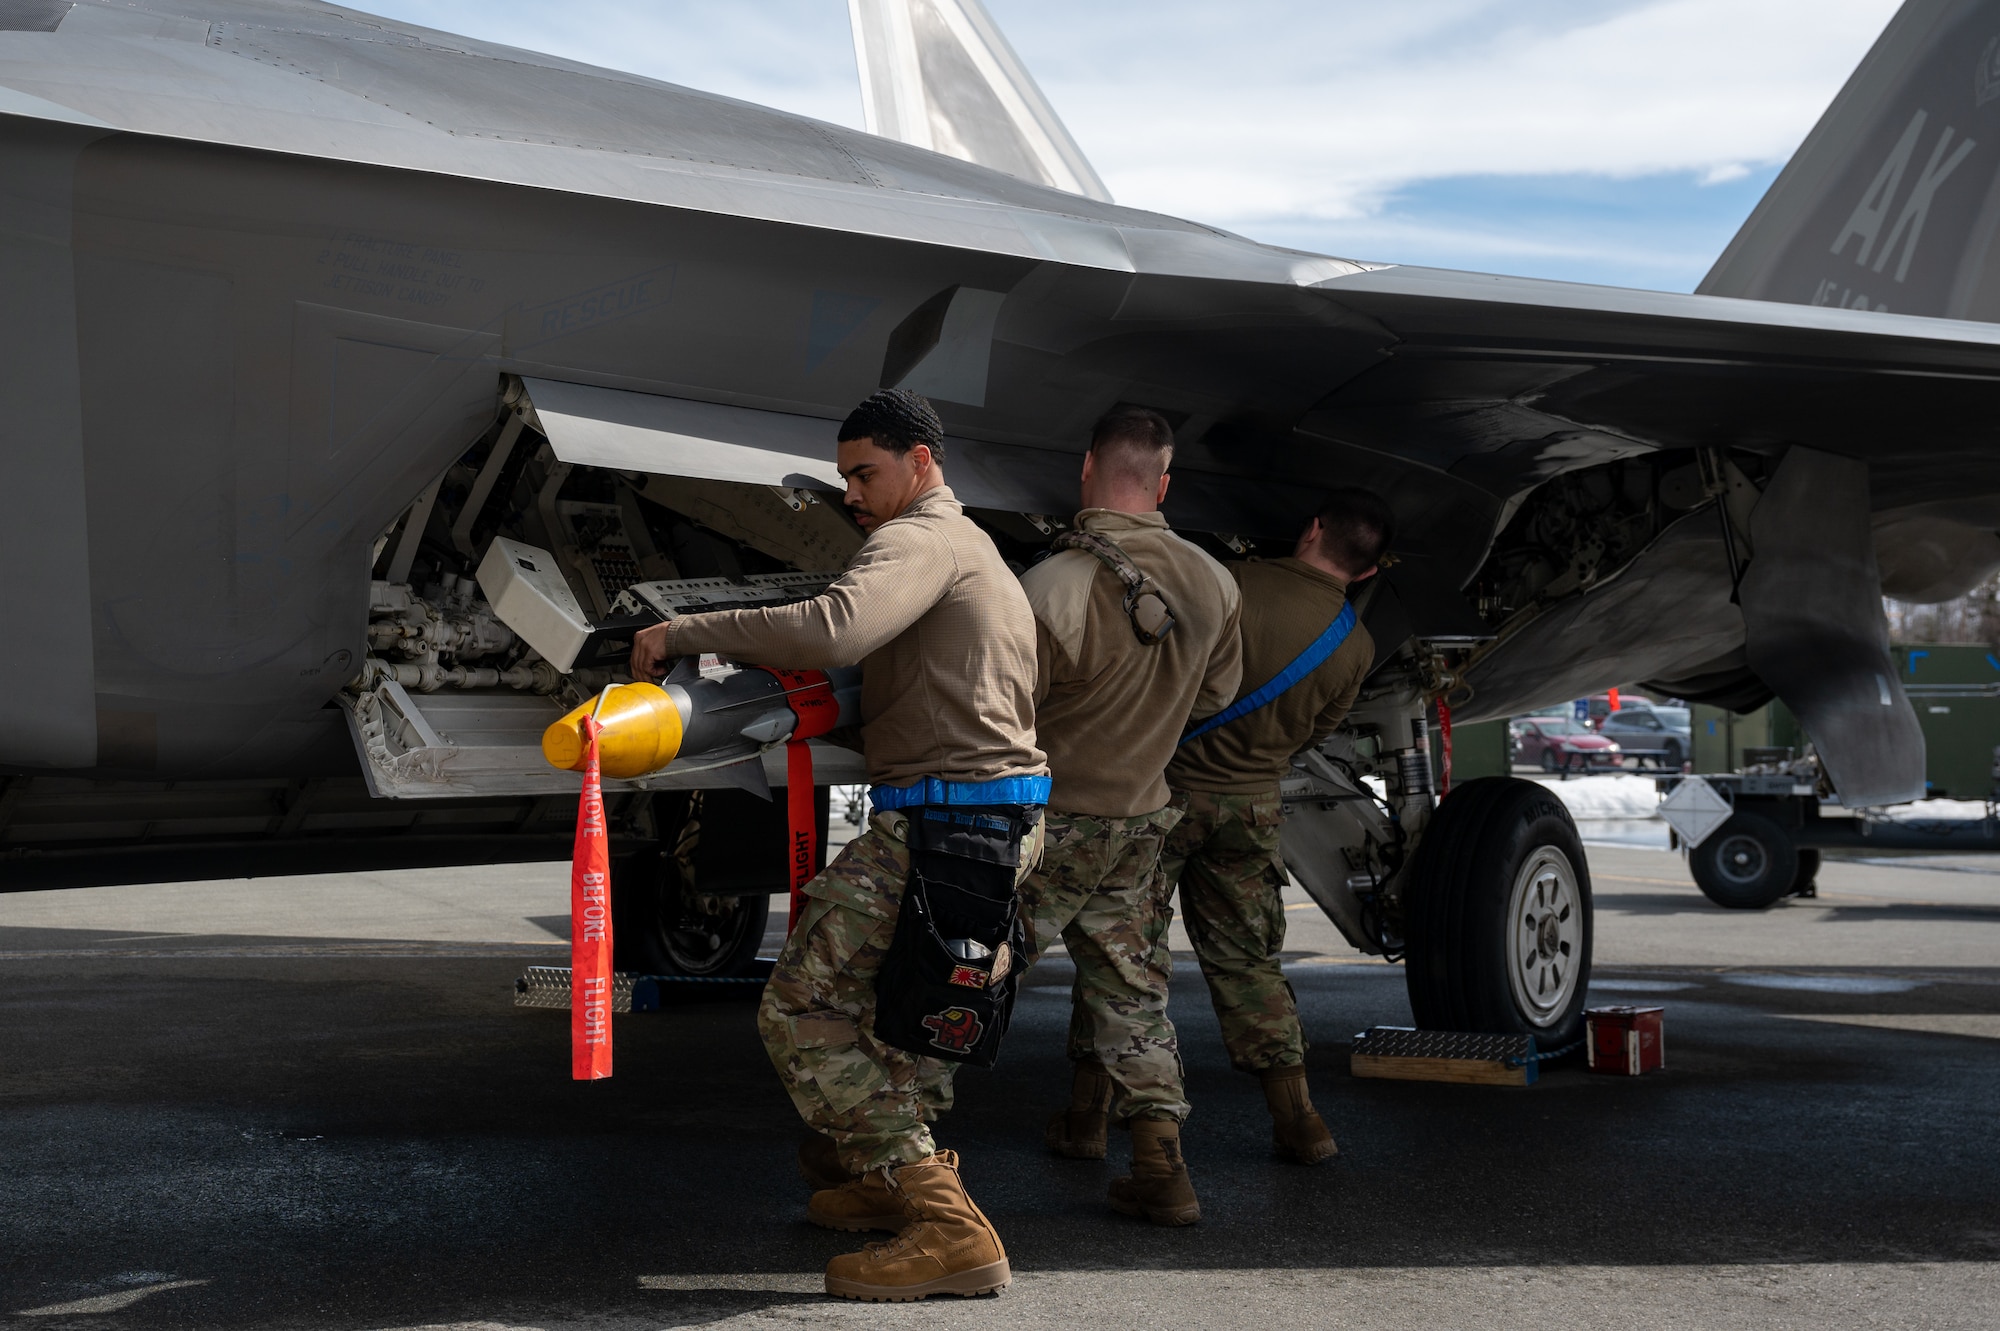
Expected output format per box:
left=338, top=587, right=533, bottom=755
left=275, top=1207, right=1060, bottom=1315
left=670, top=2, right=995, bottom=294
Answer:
left=1070, top=789, right=1306, bottom=1071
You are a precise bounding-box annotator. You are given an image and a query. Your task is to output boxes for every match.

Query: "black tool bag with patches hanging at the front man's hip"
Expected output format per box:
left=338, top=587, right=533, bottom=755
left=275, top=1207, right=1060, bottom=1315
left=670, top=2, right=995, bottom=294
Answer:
left=874, top=803, right=1042, bottom=1067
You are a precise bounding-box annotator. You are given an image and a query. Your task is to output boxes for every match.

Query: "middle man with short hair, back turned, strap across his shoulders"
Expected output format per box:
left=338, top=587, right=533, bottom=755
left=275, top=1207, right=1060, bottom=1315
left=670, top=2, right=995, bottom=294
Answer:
left=944, top=410, right=1242, bottom=1225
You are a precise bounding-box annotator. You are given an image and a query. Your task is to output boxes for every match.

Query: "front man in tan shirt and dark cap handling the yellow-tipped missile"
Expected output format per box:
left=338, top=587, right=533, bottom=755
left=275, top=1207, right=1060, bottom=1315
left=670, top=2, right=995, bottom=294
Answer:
left=632, top=390, right=1048, bottom=1299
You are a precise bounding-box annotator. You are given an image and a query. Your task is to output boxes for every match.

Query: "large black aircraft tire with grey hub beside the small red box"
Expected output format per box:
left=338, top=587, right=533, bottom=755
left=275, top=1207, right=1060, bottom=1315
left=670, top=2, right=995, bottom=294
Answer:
left=1404, top=777, right=1594, bottom=1053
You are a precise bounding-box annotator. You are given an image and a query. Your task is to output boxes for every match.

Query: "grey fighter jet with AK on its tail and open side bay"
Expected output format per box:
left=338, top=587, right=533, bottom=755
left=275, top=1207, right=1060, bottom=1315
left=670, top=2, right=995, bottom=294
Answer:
left=0, top=0, right=2000, bottom=1043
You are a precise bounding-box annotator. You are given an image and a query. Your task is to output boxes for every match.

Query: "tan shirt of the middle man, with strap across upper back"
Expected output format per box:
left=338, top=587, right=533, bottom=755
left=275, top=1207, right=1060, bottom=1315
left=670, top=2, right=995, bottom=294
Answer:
left=1020, top=508, right=1242, bottom=817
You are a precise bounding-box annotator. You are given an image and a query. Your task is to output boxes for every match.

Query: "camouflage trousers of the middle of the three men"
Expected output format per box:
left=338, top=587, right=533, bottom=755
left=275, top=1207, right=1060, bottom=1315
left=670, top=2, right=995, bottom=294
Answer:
left=926, top=807, right=1188, bottom=1121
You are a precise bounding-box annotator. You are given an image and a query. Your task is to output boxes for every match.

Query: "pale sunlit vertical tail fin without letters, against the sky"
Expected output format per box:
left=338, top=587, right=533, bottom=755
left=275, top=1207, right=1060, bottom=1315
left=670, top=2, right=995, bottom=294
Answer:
left=848, top=0, right=1112, bottom=204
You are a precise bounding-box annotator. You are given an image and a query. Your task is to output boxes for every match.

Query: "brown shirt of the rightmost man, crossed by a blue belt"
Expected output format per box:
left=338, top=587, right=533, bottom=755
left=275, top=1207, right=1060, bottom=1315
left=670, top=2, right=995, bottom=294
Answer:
left=1166, top=560, right=1374, bottom=793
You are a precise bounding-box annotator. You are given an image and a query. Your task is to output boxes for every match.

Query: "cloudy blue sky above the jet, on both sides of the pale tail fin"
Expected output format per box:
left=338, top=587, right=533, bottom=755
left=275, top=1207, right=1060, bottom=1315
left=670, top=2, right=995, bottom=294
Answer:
left=352, top=0, right=1896, bottom=290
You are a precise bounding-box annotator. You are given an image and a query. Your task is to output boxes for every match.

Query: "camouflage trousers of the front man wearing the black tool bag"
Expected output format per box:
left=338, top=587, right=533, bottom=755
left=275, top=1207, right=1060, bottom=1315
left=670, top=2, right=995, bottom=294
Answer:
left=758, top=813, right=1042, bottom=1173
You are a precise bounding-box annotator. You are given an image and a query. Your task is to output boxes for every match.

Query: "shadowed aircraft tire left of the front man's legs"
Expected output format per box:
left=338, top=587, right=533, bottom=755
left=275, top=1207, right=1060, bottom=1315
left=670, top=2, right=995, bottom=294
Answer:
left=612, top=843, right=770, bottom=975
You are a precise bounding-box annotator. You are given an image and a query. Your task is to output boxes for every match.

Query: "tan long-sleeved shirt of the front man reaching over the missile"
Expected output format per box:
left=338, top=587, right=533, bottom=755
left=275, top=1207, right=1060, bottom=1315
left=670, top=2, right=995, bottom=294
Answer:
left=666, top=486, right=1048, bottom=785
